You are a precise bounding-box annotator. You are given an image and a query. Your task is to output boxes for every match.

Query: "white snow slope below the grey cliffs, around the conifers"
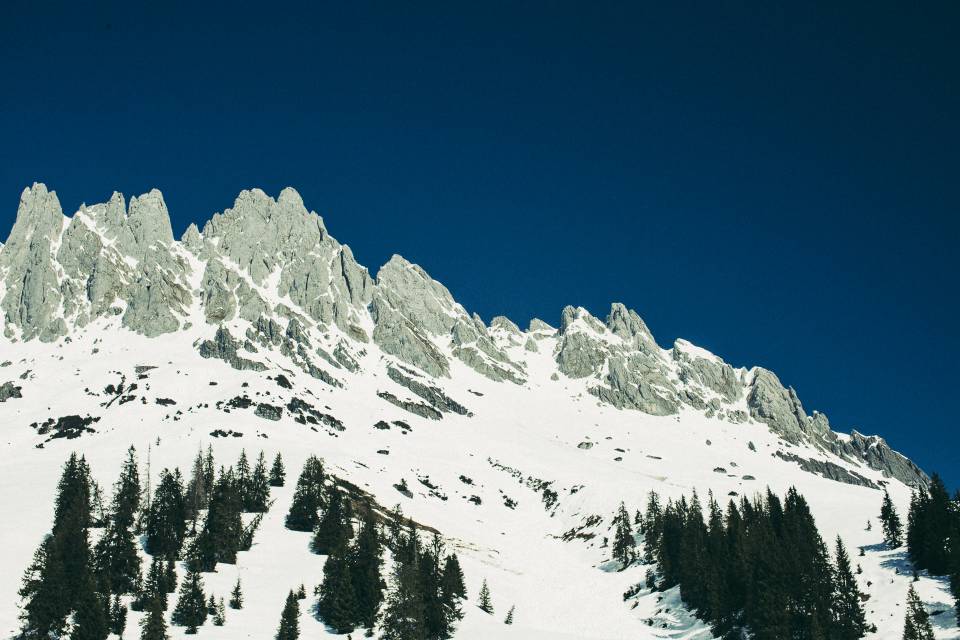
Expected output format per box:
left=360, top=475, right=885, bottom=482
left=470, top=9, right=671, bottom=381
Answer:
left=0, top=316, right=960, bottom=640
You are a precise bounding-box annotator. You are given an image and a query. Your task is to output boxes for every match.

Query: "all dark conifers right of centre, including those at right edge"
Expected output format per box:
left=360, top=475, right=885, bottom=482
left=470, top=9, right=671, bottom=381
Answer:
left=610, top=475, right=960, bottom=640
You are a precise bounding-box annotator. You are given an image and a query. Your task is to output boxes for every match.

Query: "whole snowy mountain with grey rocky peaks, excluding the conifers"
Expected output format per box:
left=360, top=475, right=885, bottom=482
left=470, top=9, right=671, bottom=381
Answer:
left=0, top=184, right=960, bottom=639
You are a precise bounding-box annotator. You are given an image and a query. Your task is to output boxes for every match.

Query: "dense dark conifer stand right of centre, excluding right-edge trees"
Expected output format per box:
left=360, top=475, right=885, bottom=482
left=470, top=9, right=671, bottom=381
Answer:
left=612, top=488, right=870, bottom=640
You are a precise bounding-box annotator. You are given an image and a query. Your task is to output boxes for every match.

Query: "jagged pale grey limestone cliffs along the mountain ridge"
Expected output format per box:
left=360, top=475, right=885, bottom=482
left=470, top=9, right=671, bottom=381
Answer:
left=0, top=184, right=928, bottom=484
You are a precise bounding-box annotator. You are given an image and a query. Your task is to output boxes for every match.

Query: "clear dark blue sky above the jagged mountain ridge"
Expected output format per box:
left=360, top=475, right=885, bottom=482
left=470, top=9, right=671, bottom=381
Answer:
left=0, top=0, right=960, bottom=486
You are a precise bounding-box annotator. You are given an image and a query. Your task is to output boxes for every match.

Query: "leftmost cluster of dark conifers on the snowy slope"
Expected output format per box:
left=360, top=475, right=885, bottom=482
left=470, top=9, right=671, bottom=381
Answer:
left=19, top=447, right=284, bottom=640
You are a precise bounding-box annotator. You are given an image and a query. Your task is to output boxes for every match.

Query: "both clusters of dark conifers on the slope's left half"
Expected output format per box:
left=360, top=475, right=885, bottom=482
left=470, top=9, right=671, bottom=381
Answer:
left=20, top=447, right=502, bottom=640
